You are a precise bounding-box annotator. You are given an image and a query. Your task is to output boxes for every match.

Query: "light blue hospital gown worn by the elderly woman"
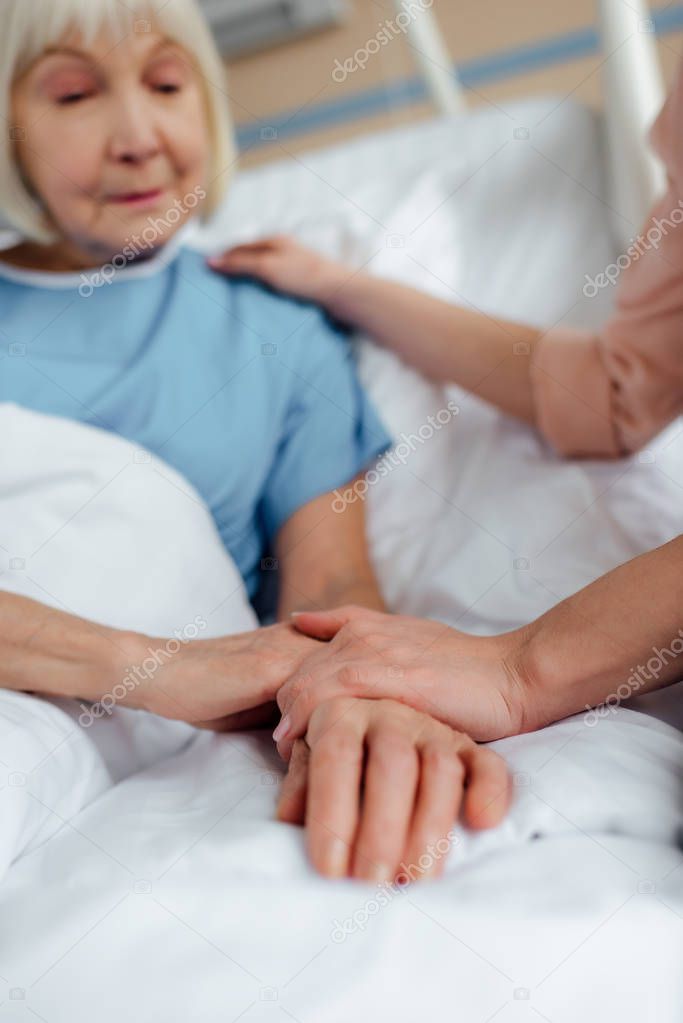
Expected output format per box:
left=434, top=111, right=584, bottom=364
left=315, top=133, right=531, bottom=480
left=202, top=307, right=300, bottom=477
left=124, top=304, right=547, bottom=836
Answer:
left=0, top=247, right=390, bottom=596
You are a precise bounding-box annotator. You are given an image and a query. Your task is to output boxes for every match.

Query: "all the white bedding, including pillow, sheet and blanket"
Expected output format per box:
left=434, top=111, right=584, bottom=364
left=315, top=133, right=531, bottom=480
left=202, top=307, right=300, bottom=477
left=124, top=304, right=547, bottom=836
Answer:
left=0, top=100, right=683, bottom=1023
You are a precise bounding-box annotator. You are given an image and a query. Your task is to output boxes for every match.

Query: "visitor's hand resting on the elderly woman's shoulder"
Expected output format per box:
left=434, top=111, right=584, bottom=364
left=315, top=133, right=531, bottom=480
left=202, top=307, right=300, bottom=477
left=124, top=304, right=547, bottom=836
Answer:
left=208, top=236, right=353, bottom=305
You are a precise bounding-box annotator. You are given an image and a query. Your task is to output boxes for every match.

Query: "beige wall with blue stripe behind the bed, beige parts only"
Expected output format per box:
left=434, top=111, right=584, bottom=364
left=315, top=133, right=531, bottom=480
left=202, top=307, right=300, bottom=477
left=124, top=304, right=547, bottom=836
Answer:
left=223, top=0, right=683, bottom=163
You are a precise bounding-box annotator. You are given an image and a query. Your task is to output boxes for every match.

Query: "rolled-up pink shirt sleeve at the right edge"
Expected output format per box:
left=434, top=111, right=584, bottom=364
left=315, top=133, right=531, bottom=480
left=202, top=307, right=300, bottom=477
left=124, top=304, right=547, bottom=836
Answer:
left=532, top=62, right=683, bottom=457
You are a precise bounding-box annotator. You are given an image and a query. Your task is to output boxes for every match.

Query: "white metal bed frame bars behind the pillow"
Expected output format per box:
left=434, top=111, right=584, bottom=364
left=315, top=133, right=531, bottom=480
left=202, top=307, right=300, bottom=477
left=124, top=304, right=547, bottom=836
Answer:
left=394, top=0, right=665, bottom=244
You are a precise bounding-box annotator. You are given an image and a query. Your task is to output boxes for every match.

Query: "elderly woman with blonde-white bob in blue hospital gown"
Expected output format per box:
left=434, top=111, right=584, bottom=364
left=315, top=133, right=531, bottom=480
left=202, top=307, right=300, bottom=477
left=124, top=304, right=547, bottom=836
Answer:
left=0, top=0, right=507, bottom=880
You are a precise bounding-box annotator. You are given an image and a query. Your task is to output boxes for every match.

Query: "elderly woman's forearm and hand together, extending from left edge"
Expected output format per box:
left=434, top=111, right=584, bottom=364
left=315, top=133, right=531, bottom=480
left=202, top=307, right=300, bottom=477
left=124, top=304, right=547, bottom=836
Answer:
left=0, top=592, right=331, bottom=730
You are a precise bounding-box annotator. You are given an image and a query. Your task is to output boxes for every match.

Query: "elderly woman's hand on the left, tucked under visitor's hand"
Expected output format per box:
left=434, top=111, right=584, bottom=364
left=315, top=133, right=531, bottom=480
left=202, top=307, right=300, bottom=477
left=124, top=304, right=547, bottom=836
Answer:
left=137, top=625, right=320, bottom=731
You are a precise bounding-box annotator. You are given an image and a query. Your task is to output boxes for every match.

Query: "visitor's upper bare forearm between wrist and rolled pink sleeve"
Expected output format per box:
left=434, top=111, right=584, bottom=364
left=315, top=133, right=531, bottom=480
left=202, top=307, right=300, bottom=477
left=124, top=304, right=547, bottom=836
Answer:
left=322, top=274, right=541, bottom=422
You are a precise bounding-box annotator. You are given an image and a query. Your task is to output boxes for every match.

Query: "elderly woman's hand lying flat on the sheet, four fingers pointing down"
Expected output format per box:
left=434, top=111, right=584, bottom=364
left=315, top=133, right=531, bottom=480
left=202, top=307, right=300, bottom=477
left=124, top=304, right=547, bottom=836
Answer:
left=278, top=699, right=510, bottom=883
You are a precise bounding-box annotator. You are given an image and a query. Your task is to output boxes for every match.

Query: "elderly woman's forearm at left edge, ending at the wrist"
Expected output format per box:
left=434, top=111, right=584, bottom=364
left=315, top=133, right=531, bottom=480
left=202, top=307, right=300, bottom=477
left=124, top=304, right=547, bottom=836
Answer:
left=0, top=592, right=143, bottom=705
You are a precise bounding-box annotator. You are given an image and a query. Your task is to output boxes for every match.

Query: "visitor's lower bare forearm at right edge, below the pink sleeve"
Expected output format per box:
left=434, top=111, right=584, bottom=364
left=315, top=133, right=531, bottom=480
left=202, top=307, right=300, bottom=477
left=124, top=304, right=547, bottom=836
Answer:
left=513, top=537, right=683, bottom=730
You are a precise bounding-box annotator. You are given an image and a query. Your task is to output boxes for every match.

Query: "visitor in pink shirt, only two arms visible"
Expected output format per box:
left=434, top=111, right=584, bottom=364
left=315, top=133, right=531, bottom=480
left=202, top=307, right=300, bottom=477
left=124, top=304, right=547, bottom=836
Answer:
left=208, top=63, right=683, bottom=757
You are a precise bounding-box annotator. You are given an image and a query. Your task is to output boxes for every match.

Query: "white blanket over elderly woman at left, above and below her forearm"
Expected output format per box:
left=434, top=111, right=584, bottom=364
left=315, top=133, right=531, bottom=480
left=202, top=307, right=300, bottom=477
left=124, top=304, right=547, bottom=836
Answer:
left=0, top=404, right=258, bottom=875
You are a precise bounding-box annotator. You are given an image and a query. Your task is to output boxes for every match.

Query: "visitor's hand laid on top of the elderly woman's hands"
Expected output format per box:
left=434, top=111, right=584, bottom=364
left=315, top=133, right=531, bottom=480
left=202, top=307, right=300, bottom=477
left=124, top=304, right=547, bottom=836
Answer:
left=274, top=608, right=525, bottom=759
